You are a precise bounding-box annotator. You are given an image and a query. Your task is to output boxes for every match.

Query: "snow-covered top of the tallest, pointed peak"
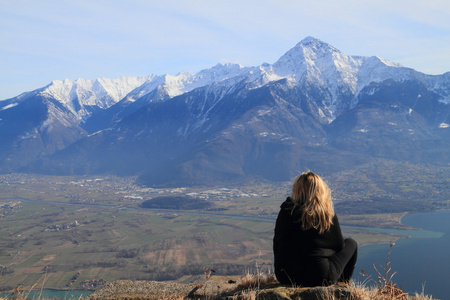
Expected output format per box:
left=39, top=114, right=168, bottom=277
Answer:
left=273, top=37, right=434, bottom=98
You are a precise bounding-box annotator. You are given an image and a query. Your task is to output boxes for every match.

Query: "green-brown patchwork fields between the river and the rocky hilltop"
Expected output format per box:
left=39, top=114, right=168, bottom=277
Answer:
left=0, top=199, right=404, bottom=289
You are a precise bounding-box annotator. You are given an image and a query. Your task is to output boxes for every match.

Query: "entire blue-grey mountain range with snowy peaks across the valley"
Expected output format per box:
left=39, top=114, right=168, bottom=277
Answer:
left=0, top=37, right=450, bottom=186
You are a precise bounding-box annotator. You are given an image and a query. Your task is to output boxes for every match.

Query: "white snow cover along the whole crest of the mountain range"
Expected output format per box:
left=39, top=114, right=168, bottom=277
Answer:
left=9, top=37, right=450, bottom=126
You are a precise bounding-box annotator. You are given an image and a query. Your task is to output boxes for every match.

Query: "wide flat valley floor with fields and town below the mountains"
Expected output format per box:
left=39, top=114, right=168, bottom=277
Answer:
left=0, top=161, right=450, bottom=290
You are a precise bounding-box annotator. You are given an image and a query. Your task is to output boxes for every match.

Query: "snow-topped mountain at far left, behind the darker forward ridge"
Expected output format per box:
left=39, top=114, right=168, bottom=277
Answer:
left=0, top=77, right=153, bottom=170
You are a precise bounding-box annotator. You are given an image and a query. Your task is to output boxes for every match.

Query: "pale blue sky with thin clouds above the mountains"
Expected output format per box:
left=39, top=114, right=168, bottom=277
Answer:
left=0, top=0, right=450, bottom=100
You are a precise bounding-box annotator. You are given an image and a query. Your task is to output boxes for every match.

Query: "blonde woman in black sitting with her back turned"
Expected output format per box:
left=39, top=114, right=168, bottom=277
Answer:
left=273, top=172, right=358, bottom=286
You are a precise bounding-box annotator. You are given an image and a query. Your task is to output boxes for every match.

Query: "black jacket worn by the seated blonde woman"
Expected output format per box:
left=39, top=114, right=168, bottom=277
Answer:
left=273, top=197, right=344, bottom=286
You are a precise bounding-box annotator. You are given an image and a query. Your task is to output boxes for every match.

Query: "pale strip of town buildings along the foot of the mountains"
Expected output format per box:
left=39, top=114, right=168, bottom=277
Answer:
left=0, top=173, right=289, bottom=206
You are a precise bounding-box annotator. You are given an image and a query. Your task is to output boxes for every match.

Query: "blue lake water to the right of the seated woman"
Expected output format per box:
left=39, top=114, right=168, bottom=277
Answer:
left=354, top=211, right=450, bottom=299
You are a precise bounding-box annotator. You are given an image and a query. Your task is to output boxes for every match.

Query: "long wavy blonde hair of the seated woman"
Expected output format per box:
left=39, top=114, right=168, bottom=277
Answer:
left=291, top=171, right=334, bottom=233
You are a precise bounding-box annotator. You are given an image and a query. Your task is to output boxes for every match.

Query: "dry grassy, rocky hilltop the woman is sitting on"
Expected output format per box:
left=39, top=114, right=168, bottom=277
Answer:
left=84, top=274, right=433, bottom=300
